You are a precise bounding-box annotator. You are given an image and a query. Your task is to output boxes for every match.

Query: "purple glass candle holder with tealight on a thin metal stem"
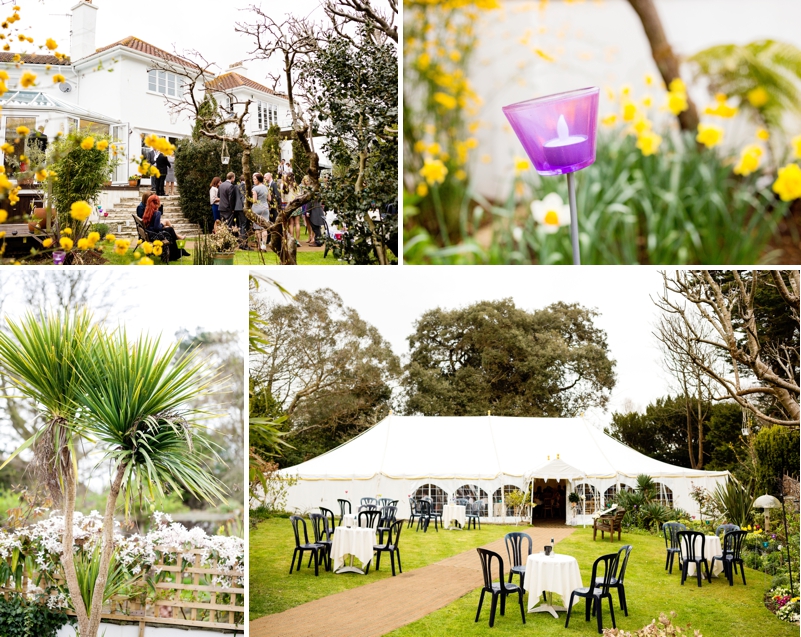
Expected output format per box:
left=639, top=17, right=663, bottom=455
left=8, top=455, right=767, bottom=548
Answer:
left=503, top=87, right=599, bottom=265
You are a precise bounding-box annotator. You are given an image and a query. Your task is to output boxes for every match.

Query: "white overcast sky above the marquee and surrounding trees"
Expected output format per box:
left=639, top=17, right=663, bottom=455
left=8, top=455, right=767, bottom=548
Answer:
left=252, top=266, right=669, bottom=426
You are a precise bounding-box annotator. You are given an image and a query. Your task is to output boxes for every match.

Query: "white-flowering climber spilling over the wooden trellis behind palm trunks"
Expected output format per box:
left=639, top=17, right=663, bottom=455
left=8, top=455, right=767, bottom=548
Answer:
left=0, top=511, right=245, bottom=620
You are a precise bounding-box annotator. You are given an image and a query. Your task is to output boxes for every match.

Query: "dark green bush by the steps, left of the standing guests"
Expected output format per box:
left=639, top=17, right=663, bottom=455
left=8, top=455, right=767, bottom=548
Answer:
left=175, top=137, right=242, bottom=232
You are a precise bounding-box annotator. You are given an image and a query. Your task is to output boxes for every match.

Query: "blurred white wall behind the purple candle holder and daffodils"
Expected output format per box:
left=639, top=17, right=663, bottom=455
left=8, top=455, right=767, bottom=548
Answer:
left=470, top=0, right=801, bottom=197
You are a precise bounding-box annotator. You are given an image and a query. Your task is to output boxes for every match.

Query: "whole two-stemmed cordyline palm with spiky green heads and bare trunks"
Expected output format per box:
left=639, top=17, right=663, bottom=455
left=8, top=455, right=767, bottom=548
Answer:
left=0, top=311, right=224, bottom=637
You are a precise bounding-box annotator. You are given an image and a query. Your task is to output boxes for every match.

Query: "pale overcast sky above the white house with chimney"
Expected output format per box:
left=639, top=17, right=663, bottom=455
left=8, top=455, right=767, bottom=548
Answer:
left=18, top=0, right=325, bottom=86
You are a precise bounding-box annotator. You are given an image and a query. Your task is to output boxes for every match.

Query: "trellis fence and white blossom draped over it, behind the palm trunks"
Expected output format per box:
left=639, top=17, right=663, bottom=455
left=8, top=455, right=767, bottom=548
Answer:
left=0, top=511, right=245, bottom=629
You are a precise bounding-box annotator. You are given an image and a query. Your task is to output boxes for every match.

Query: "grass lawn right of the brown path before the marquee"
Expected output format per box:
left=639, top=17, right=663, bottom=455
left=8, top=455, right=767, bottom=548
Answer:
left=386, top=525, right=798, bottom=637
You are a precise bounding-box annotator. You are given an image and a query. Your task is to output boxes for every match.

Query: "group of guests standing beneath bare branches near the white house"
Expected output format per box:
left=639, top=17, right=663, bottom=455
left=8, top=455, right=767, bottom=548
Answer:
left=209, top=165, right=324, bottom=250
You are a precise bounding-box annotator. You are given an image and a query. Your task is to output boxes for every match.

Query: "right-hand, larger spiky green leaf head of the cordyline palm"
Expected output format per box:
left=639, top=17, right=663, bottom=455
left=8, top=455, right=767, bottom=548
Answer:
left=78, top=330, right=225, bottom=513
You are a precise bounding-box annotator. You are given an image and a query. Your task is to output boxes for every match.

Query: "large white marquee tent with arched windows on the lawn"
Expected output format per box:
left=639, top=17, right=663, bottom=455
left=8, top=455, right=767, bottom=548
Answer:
left=272, top=415, right=729, bottom=524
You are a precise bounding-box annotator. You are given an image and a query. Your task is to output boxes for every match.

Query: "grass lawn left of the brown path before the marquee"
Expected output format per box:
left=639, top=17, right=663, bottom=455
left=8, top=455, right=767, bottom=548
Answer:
left=248, top=518, right=528, bottom=620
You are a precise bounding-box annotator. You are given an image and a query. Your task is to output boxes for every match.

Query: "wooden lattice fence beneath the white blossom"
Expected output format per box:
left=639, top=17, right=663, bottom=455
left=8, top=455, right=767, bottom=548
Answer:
left=0, top=547, right=245, bottom=637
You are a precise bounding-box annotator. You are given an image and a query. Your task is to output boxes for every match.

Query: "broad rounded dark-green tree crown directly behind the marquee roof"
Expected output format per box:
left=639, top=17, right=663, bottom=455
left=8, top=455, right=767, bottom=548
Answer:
left=403, top=299, right=615, bottom=417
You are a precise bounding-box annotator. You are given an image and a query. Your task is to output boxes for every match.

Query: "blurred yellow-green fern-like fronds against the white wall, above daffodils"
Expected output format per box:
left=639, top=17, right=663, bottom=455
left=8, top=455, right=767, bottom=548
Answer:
left=689, top=40, right=801, bottom=128
